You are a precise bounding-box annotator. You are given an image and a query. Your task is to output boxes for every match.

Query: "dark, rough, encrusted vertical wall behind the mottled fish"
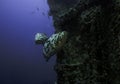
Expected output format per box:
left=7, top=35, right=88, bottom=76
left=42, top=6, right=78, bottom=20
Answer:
left=48, top=0, right=120, bottom=84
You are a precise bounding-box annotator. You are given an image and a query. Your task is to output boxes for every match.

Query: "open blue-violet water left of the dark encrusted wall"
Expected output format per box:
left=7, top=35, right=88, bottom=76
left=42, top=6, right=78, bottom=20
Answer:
left=0, top=0, right=56, bottom=84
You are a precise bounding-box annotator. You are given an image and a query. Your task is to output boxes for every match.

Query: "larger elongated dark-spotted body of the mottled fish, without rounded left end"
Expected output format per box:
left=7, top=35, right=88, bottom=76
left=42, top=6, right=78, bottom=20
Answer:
left=43, top=31, right=68, bottom=61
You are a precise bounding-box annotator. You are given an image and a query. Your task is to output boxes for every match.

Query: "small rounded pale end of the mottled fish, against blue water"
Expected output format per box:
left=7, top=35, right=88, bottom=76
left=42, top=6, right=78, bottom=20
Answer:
left=35, top=33, right=48, bottom=44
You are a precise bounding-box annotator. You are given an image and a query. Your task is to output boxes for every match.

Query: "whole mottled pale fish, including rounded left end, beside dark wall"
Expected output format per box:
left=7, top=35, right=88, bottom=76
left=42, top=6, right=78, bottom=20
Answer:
left=35, top=31, right=68, bottom=61
